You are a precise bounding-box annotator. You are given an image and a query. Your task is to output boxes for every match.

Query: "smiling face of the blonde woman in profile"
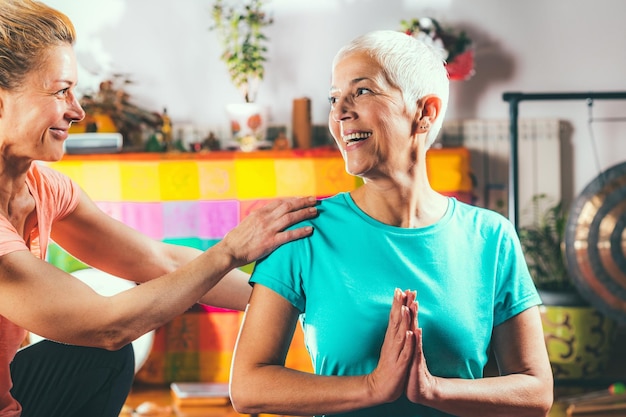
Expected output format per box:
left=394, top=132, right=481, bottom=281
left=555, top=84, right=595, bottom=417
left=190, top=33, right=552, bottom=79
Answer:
left=0, top=45, right=85, bottom=162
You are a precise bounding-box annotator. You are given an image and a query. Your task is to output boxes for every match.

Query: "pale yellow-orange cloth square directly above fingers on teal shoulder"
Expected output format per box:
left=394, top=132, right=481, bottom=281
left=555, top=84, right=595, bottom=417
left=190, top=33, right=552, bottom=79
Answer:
left=274, top=158, right=315, bottom=197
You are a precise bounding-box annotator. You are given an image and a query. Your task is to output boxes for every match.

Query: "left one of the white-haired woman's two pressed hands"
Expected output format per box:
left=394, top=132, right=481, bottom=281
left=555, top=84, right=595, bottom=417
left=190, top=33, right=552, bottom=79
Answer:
left=367, top=289, right=417, bottom=403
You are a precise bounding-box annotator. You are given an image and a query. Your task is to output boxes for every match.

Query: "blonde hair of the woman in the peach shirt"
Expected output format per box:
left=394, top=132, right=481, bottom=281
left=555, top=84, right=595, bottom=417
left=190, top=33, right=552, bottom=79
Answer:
left=0, top=0, right=76, bottom=90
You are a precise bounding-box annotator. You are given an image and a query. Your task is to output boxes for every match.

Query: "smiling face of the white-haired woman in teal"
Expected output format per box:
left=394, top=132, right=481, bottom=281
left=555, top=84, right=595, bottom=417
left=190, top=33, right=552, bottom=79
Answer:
left=328, top=52, right=414, bottom=179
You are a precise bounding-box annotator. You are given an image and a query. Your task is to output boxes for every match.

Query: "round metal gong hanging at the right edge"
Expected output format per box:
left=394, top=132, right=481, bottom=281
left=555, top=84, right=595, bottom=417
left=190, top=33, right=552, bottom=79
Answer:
left=565, top=162, right=626, bottom=323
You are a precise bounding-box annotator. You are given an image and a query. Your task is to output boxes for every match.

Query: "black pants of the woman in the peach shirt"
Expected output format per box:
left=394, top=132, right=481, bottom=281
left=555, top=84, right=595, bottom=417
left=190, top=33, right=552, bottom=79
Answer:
left=11, top=340, right=135, bottom=417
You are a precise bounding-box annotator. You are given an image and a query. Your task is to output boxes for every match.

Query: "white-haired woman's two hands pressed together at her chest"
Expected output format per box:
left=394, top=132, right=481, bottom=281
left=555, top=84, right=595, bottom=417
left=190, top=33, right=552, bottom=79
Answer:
left=368, top=289, right=435, bottom=403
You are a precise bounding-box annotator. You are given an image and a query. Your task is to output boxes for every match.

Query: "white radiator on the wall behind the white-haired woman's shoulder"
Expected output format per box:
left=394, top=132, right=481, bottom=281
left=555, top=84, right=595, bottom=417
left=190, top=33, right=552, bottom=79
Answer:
left=439, top=119, right=566, bottom=225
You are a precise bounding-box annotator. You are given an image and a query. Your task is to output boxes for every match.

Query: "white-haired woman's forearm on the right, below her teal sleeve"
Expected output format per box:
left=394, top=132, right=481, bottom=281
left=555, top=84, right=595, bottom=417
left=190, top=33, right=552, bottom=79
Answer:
left=423, top=374, right=553, bottom=417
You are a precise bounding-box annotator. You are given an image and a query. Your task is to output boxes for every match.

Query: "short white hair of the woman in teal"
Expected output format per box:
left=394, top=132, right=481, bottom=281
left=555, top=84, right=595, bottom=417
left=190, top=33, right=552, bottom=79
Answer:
left=332, top=30, right=450, bottom=147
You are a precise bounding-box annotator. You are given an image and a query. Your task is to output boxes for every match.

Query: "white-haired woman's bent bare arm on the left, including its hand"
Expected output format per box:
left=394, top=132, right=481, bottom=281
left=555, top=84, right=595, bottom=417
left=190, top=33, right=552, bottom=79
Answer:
left=231, top=284, right=413, bottom=415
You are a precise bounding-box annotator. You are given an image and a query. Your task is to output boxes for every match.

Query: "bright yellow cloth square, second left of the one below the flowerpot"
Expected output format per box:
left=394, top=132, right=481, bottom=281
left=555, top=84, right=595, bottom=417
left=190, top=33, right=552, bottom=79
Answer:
left=159, top=161, right=200, bottom=201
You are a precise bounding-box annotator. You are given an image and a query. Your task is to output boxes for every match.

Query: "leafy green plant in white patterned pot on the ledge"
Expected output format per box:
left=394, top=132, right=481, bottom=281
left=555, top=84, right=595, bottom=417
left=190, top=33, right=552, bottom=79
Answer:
left=211, top=0, right=274, bottom=150
